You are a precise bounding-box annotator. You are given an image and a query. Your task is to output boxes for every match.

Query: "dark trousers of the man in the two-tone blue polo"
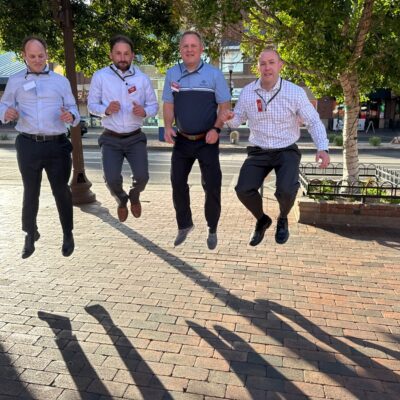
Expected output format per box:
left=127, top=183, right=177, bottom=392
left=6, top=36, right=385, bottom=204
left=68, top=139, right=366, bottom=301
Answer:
left=171, top=136, right=222, bottom=230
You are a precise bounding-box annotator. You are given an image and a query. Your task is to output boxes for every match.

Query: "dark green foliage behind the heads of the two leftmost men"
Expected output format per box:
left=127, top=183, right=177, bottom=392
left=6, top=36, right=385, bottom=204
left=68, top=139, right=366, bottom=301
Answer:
left=0, top=0, right=178, bottom=75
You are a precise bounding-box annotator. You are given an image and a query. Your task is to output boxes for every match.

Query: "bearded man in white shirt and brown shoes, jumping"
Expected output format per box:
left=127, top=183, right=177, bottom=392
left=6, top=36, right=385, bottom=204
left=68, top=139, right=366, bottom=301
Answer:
left=88, top=35, right=158, bottom=222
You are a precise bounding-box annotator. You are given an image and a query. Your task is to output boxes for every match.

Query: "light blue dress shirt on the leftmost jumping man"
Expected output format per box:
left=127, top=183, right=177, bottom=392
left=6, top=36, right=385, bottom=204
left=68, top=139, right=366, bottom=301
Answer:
left=0, top=70, right=80, bottom=135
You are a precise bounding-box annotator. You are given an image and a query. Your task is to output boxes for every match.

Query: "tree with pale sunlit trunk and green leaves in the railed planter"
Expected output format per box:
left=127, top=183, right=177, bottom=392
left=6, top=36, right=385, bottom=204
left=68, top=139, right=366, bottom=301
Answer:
left=176, top=0, right=400, bottom=180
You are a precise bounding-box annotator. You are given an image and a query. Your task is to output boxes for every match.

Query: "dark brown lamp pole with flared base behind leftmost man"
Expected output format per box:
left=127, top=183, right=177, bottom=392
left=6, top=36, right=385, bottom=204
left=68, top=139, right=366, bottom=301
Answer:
left=56, top=0, right=96, bottom=205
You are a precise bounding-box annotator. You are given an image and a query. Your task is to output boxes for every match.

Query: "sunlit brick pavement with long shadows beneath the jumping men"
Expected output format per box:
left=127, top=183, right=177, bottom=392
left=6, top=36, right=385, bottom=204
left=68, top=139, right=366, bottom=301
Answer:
left=0, top=176, right=400, bottom=400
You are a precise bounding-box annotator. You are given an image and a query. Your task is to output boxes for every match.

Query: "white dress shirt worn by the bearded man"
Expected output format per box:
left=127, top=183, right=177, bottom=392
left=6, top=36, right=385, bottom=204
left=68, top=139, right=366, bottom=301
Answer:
left=88, top=65, right=158, bottom=133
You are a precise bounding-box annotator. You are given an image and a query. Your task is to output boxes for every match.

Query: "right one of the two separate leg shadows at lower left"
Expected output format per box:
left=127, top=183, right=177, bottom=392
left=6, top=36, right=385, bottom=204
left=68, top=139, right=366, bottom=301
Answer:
left=85, top=304, right=173, bottom=400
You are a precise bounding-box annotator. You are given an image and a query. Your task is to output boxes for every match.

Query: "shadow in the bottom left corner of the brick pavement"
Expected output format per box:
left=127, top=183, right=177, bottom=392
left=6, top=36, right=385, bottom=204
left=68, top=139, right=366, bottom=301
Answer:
left=0, top=342, right=34, bottom=400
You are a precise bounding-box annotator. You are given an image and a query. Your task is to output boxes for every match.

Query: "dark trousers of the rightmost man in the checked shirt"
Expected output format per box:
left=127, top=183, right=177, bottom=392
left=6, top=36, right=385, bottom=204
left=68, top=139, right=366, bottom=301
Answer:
left=235, top=144, right=301, bottom=220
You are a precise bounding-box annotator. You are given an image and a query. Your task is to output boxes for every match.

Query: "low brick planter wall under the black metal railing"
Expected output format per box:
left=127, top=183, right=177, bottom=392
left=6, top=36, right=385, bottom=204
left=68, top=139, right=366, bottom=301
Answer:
left=293, top=196, right=400, bottom=229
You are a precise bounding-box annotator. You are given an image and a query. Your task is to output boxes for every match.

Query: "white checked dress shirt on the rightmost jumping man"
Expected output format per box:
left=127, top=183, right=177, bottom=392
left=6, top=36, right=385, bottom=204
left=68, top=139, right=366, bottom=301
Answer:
left=227, top=78, right=329, bottom=150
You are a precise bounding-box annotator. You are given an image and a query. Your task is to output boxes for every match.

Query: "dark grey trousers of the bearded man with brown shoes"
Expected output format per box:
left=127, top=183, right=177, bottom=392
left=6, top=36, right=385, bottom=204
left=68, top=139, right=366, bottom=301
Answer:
left=99, top=132, right=149, bottom=205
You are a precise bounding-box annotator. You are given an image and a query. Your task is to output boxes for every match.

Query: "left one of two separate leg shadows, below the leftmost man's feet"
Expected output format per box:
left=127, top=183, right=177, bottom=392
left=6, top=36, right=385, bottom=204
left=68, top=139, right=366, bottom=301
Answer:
left=38, top=311, right=113, bottom=400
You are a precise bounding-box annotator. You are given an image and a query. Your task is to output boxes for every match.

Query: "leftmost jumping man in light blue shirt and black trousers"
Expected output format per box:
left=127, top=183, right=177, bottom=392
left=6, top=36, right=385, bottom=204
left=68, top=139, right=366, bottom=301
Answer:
left=0, top=36, right=80, bottom=258
